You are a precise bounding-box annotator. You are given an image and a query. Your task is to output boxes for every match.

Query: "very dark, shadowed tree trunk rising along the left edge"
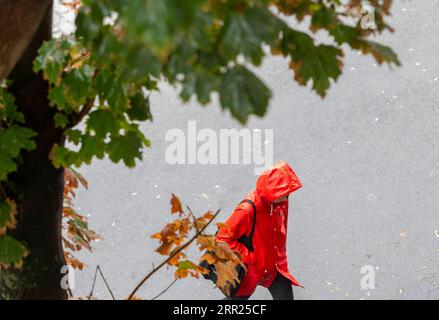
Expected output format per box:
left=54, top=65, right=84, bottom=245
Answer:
left=0, top=1, right=67, bottom=299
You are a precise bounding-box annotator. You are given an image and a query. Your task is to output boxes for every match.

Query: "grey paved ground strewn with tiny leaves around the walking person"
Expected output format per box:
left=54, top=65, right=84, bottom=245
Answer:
left=60, top=0, right=439, bottom=299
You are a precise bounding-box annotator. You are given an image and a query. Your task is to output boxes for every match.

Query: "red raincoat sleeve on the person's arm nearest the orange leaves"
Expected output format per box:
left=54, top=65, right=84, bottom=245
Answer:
left=216, top=202, right=253, bottom=263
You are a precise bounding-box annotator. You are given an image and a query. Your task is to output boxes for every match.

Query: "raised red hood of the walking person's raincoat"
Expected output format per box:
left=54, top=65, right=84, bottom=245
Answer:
left=256, top=160, right=302, bottom=203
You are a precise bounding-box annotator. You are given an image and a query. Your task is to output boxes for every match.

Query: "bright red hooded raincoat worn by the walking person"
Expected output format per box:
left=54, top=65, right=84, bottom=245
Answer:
left=216, top=161, right=302, bottom=296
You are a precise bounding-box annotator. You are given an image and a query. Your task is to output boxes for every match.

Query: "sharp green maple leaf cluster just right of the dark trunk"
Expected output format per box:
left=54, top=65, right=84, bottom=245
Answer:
left=34, top=38, right=151, bottom=167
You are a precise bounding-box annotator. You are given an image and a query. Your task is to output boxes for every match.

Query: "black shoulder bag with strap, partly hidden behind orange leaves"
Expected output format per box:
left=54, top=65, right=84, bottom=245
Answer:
left=200, top=199, right=256, bottom=297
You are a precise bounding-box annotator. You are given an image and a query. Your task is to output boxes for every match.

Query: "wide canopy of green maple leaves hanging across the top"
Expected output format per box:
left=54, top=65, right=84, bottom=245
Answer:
left=34, top=0, right=399, bottom=167
